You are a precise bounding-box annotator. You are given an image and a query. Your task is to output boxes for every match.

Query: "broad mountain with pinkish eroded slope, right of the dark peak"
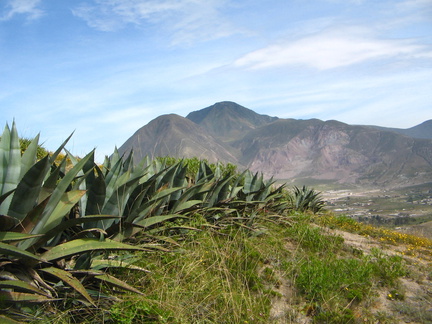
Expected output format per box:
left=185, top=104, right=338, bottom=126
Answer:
left=233, top=119, right=432, bottom=185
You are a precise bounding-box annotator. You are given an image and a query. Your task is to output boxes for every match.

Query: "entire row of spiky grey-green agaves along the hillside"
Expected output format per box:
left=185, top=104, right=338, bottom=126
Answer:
left=0, top=123, right=308, bottom=319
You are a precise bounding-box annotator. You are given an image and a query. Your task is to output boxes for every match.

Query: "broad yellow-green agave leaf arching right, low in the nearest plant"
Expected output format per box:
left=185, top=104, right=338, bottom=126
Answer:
left=42, top=238, right=145, bottom=261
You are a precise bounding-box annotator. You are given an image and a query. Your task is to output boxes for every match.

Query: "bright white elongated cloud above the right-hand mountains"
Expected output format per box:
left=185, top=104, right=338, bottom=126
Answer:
left=234, top=30, right=422, bottom=70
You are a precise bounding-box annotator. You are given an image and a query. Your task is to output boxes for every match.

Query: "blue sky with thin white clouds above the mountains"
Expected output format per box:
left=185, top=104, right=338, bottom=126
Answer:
left=0, top=0, right=432, bottom=160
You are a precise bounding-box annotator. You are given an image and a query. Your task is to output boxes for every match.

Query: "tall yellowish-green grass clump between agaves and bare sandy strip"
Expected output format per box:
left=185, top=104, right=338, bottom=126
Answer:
left=114, top=229, right=271, bottom=323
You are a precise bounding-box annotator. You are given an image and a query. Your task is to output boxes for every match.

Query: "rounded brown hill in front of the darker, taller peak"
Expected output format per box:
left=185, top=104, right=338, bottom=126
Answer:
left=118, top=114, right=236, bottom=163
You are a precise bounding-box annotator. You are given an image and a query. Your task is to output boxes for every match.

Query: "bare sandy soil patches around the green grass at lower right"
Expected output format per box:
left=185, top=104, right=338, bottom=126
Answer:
left=270, top=230, right=432, bottom=324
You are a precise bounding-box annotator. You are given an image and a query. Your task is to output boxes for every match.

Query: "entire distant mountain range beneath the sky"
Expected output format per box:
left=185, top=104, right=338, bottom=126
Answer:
left=119, top=101, right=432, bottom=186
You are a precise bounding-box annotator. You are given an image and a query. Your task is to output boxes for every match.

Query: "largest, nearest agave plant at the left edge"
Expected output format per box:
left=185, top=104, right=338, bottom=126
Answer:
left=0, top=123, right=155, bottom=322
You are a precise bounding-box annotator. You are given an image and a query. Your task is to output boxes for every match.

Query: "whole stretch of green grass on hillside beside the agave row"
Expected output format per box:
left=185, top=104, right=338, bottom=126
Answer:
left=19, top=214, right=429, bottom=324
